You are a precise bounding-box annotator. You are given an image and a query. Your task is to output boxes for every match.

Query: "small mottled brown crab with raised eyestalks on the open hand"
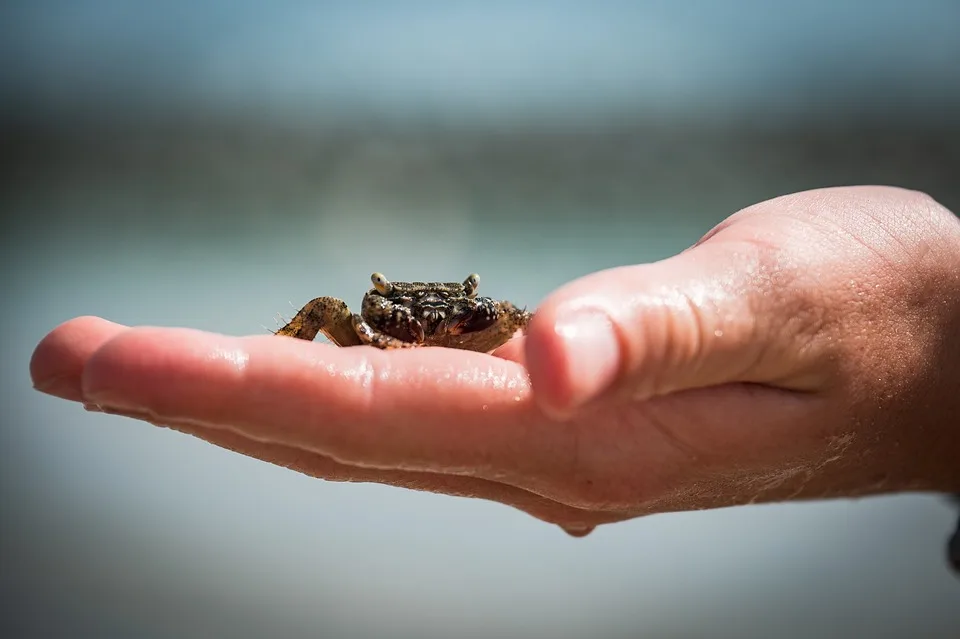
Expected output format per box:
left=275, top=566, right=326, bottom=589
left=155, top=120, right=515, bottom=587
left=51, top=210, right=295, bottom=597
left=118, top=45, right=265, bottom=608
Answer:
left=276, top=273, right=532, bottom=353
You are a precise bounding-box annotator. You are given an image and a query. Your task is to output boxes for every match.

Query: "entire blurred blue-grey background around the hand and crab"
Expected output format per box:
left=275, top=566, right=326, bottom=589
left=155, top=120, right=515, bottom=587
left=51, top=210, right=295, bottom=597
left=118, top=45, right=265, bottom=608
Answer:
left=0, top=0, right=960, bottom=638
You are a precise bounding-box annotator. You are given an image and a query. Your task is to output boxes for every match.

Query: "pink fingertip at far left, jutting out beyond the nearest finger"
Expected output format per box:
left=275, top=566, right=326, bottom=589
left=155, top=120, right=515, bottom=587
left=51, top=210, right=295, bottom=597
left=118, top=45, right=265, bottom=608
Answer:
left=30, top=316, right=128, bottom=401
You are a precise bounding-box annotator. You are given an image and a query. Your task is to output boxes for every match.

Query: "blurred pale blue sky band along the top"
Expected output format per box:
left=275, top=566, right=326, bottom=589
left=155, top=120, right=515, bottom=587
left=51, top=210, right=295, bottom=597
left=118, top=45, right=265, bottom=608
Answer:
left=0, top=0, right=960, bottom=123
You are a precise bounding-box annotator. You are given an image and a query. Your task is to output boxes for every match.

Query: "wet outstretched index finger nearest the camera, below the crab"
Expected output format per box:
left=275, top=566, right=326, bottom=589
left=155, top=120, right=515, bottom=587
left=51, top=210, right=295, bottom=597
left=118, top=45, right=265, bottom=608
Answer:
left=83, top=328, right=572, bottom=479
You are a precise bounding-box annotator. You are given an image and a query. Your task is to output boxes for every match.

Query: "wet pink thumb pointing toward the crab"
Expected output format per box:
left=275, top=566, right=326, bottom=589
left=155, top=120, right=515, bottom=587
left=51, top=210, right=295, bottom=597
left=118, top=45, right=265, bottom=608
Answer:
left=524, top=232, right=824, bottom=417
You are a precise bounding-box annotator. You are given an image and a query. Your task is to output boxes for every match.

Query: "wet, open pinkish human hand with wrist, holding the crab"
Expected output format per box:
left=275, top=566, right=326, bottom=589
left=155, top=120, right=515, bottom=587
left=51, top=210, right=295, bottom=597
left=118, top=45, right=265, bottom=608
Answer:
left=31, top=187, right=960, bottom=535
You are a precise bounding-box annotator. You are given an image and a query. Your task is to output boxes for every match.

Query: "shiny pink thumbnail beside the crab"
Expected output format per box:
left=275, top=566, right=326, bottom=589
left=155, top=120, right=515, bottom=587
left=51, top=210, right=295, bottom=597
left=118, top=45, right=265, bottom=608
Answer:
left=554, top=309, right=620, bottom=410
